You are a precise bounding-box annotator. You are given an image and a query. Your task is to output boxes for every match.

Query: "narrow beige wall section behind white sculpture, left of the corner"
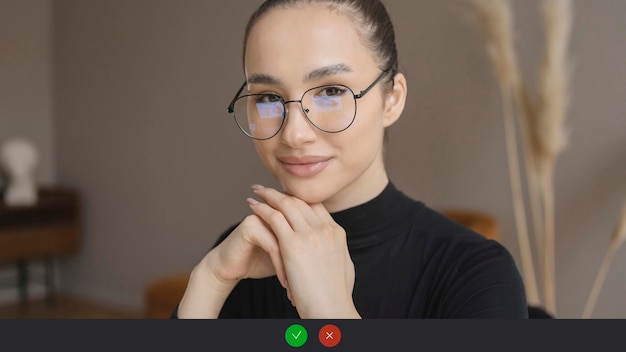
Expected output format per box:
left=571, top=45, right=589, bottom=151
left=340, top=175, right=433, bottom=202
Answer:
left=0, top=0, right=56, bottom=184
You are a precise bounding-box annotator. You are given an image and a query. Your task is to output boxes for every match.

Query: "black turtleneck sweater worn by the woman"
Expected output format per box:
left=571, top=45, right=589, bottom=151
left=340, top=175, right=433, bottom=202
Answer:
left=182, top=183, right=528, bottom=318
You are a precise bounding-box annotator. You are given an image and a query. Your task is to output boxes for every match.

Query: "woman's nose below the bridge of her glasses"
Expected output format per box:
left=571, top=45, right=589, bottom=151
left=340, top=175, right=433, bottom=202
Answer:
left=280, top=100, right=317, bottom=148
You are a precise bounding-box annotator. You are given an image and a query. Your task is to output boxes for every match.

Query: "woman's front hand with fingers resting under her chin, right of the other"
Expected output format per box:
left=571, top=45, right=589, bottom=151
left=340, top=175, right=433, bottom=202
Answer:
left=248, top=186, right=359, bottom=318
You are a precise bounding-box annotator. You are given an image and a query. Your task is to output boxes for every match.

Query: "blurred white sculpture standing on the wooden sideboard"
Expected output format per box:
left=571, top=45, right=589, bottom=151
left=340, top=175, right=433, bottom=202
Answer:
left=0, top=138, right=39, bottom=206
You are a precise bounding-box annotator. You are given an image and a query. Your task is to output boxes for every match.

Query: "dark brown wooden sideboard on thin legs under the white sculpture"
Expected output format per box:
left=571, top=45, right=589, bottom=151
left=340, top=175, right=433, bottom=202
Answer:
left=0, top=188, right=81, bottom=302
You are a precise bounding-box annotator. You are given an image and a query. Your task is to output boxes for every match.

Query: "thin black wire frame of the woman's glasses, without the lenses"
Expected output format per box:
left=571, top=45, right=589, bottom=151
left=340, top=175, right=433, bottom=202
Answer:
left=227, top=67, right=392, bottom=140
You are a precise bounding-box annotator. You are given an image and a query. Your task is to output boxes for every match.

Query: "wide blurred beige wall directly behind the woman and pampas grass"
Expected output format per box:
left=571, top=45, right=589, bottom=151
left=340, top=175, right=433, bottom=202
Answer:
left=0, top=0, right=626, bottom=318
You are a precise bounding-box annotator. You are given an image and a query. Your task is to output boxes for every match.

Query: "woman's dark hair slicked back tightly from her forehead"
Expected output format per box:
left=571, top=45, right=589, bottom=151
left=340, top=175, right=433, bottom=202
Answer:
left=243, top=0, right=398, bottom=85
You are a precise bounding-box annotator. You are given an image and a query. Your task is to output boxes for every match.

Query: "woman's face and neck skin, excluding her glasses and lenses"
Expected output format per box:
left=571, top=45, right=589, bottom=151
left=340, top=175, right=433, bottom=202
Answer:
left=245, top=5, right=404, bottom=212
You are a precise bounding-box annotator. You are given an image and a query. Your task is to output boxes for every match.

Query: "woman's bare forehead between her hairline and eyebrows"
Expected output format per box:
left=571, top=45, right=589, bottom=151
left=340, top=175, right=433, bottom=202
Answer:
left=244, top=5, right=376, bottom=78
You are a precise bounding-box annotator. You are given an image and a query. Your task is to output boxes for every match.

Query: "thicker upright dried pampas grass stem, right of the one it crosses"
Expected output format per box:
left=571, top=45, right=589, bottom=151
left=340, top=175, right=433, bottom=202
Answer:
left=528, top=0, right=573, bottom=314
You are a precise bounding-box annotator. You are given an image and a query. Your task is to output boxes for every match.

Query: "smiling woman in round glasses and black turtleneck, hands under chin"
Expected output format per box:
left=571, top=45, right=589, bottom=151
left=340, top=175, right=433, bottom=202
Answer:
left=174, top=0, right=527, bottom=319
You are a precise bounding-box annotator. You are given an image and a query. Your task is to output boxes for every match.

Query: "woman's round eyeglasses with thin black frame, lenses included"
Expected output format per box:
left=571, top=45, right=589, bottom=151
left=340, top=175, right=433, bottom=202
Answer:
left=228, top=69, right=391, bottom=140
